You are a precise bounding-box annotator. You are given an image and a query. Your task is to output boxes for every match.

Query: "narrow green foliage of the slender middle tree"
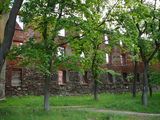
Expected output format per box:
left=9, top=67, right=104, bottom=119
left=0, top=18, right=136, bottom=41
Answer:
left=71, top=1, right=110, bottom=81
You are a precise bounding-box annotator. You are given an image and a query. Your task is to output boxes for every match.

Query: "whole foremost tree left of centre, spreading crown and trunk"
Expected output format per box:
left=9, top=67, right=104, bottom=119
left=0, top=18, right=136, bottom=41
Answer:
left=13, top=0, right=109, bottom=110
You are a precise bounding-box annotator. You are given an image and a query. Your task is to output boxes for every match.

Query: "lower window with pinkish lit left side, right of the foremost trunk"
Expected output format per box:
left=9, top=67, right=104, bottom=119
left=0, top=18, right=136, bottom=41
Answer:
left=58, top=71, right=66, bottom=85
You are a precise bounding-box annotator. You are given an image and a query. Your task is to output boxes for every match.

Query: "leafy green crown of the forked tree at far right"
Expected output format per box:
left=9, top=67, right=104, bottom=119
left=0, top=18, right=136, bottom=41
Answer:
left=109, top=0, right=160, bottom=61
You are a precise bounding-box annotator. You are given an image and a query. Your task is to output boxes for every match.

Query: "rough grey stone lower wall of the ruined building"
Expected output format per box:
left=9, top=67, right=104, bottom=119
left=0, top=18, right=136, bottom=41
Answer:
left=6, top=69, right=144, bottom=96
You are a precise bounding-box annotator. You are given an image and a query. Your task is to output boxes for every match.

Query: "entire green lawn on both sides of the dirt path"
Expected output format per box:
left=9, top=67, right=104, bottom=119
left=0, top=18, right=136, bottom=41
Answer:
left=0, top=93, right=160, bottom=120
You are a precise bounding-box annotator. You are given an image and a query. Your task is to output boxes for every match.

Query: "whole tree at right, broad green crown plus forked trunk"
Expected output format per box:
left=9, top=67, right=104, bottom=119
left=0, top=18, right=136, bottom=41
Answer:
left=109, top=0, right=160, bottom=105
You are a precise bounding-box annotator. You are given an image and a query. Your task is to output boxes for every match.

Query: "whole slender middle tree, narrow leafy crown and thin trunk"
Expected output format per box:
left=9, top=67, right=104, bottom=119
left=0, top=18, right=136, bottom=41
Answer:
left=71, top=0, right=117, bottom=100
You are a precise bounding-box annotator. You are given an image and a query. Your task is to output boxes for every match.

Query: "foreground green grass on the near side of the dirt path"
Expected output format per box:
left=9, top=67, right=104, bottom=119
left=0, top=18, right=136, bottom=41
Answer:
left=0, top=107, right=160, bottom=120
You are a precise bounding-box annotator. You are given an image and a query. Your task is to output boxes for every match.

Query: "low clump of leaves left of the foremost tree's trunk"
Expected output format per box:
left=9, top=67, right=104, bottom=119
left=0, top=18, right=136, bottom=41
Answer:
left=9, top=39, right=51, bottom=74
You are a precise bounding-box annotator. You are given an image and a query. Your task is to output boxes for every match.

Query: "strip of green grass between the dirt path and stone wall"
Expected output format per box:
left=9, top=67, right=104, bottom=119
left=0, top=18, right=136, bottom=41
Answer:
left=0, top=93, right=160, bottom=113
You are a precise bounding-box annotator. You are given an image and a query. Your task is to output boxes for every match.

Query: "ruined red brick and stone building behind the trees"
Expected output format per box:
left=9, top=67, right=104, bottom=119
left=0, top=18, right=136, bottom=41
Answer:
left=6, top=24, right=156, bottom=96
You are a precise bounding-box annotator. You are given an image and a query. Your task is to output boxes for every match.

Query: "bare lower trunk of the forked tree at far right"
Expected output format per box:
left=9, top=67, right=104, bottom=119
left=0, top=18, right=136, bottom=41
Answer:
left=142, top=62, right=148, bottom=106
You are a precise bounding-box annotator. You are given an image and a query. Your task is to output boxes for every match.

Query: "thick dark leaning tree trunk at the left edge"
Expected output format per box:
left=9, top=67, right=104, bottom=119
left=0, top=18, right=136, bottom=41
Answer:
left=0, top=0, right=23, bottom=72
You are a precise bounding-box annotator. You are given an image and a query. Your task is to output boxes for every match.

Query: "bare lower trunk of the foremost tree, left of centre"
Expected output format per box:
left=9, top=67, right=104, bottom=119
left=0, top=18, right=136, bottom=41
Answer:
left=44, top=76, right=50, bottom=111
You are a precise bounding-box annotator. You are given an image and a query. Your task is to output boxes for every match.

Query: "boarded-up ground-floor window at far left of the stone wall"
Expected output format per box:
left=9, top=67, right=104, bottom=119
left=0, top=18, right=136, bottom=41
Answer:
left=11, top=70, right=22, bottom=86
